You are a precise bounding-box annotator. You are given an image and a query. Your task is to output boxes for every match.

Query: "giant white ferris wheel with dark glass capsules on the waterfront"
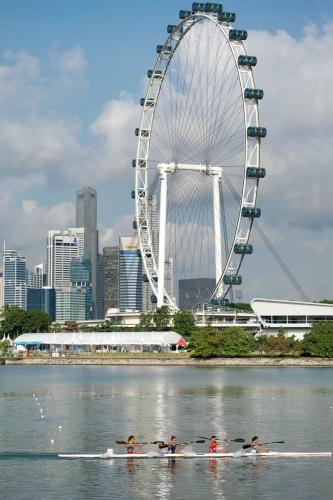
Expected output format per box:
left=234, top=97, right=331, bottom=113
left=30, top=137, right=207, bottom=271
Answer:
left=132, top=3, right=267, bottom=310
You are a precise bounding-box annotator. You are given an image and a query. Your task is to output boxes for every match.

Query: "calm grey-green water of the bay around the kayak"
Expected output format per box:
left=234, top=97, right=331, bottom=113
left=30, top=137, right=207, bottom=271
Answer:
left=0, top=366, right=333, bottom=500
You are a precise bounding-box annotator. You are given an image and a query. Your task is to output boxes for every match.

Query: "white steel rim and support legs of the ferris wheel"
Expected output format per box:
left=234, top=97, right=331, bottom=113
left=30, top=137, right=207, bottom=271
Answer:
left=135, top=12, right=260, bottom=310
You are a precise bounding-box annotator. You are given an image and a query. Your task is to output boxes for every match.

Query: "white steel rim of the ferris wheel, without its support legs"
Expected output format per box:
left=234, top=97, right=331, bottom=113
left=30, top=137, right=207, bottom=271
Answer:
left=135, top=12, right=260, bottom=310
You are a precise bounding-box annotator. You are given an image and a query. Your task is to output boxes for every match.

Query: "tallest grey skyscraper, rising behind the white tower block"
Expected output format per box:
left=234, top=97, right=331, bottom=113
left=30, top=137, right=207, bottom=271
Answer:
left=76, top=187, right=98, bottom=317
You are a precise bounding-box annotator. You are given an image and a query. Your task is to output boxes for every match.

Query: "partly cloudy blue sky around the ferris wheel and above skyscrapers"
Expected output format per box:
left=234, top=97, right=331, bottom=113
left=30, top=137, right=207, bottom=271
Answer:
left=0, top=1, right=333, bottom=300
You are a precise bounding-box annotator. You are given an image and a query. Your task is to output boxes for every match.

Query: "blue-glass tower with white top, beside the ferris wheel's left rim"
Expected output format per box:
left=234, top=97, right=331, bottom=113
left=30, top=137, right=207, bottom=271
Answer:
left=119, top=235, right=142, bottom=311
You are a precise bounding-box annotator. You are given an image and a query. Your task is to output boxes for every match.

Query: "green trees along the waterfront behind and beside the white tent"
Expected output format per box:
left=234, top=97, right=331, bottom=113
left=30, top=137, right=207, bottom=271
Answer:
left=0, top=306, right=333, bottom=358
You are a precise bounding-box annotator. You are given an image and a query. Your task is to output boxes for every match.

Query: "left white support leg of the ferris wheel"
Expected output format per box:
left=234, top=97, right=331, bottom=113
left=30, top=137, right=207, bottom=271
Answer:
left=157, top=170, right=168, bottom=307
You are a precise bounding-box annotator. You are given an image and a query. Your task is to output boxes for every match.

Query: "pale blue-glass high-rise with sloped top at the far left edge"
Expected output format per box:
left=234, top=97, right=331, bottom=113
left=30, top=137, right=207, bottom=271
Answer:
left=3, top=249, right=27, bottom=310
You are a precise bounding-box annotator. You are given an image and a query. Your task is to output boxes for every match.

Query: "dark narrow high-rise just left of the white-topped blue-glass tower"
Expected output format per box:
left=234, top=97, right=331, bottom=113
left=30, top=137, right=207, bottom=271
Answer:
left=103, top=246, right=119, bottom=313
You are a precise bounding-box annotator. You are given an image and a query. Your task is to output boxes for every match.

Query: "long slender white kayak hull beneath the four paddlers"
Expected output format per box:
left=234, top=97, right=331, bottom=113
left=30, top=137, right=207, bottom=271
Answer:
left=58, top=451, right=332, bottom=460
